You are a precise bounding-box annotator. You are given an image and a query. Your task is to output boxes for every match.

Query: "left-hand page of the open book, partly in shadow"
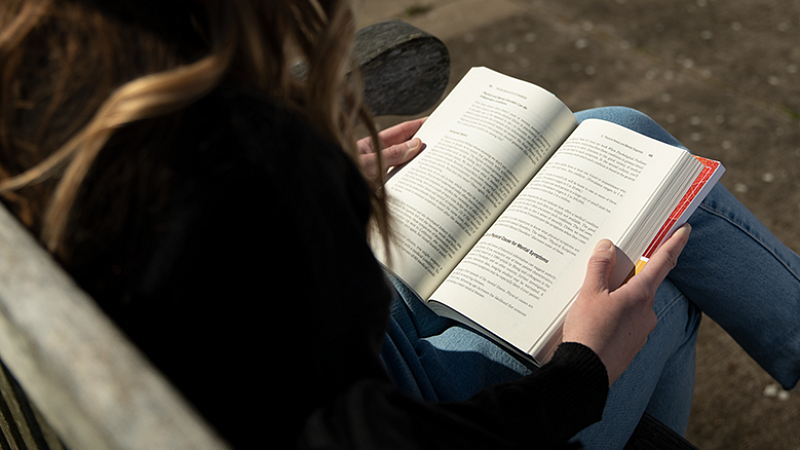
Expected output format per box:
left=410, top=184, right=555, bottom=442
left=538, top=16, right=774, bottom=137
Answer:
left=374, top=68, right=577, bottom=298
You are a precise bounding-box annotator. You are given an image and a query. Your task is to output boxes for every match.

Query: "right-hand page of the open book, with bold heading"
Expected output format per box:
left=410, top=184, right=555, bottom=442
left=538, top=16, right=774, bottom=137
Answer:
left=432, top=120, right=699, bottom=358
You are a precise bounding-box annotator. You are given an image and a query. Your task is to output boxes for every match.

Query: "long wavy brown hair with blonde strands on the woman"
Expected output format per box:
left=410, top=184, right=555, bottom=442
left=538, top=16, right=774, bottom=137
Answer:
left=0, top=0, right=388, bottom=258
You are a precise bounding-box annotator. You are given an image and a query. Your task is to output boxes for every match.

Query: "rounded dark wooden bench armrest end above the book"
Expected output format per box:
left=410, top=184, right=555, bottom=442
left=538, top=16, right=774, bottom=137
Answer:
left=354, top=20, right=450, bottom=116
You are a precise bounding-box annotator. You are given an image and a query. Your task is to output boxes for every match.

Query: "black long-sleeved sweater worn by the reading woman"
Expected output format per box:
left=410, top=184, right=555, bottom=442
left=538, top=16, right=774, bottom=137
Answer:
left=70, top=88, right=607, bottom=449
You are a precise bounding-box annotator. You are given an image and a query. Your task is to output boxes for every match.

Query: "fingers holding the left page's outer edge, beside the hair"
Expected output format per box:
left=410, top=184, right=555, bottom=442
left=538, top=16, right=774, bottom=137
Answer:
left=358, top=117, right=427, bottom=182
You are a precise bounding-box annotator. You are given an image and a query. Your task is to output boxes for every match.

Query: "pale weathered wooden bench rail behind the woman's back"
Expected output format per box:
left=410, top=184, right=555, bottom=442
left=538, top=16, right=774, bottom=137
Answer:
left=0, top=208, right=227, bottom=450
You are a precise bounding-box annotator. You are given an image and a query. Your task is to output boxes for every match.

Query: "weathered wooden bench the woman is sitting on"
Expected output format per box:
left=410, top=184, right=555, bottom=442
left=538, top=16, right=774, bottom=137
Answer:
left=0, top=21, right=693, bottom=450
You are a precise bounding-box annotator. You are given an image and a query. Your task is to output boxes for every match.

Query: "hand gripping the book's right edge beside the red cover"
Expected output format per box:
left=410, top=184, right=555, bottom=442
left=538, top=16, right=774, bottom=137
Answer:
left=562, top=224, right=691, bottom=386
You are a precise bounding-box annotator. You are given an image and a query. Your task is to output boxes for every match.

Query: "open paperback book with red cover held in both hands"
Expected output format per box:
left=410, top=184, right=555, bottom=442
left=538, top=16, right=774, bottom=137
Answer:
left=373, top=68, right=724, bottom=364
